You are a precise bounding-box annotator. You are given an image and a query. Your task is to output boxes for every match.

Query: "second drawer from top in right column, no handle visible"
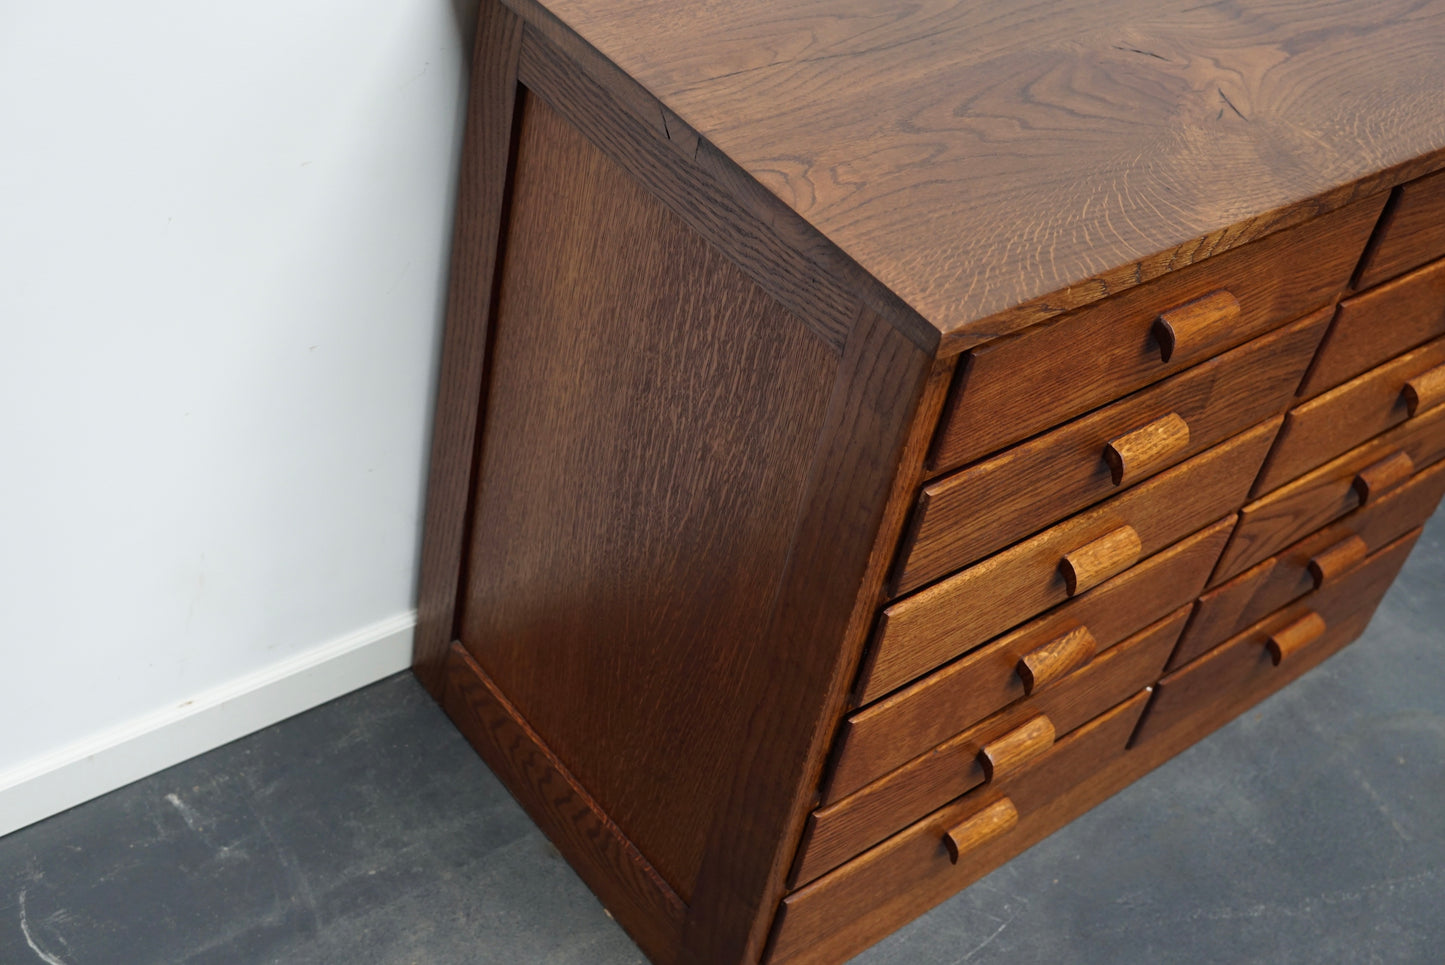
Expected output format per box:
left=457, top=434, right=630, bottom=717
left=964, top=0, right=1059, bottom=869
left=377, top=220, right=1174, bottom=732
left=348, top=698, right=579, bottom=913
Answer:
left=1299, top=259, right=1445, bottom=399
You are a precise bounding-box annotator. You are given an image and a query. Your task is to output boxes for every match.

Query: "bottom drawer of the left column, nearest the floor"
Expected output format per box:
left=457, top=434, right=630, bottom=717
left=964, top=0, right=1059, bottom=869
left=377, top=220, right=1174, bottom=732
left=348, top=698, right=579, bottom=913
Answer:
left=766, top=693, right=1147, bottom=965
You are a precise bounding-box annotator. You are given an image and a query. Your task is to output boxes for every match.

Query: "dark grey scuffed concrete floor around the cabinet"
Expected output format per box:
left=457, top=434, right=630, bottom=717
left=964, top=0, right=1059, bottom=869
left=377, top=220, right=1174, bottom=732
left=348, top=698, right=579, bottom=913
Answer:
left=0, top=514, right=1445, bottom=965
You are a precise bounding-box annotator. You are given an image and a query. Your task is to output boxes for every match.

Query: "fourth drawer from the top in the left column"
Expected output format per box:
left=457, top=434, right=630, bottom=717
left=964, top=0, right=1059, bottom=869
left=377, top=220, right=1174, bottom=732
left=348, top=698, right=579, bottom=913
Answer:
left=843, top=516, right=1234, bottom=774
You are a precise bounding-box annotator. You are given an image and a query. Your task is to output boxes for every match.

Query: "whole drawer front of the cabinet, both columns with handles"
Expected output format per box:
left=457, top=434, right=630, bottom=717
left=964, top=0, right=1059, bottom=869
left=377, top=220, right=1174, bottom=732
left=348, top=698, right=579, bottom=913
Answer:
left=769, top=175, right=1445, bottom=962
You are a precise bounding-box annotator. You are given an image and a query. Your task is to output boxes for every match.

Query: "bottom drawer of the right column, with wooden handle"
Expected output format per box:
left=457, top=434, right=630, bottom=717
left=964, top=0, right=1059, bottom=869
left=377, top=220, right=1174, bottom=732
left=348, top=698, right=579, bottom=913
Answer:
left=1133, top=529, right=1420, bottom=745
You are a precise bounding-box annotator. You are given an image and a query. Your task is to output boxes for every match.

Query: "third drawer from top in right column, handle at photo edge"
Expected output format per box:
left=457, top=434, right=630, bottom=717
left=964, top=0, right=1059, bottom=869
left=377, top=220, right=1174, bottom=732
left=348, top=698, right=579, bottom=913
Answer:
left=1253, top=338, right=1445, bottom=496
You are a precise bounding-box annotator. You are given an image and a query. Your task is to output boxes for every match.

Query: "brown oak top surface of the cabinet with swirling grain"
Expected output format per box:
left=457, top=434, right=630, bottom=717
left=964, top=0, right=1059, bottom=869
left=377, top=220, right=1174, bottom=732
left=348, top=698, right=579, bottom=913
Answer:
left=525, top=0, right=1445, bottom=341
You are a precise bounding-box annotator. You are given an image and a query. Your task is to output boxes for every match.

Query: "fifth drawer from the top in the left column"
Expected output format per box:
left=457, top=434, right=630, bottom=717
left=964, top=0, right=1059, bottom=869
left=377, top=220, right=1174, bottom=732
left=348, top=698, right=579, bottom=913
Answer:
left=795, top=605, right=1189, bottom=883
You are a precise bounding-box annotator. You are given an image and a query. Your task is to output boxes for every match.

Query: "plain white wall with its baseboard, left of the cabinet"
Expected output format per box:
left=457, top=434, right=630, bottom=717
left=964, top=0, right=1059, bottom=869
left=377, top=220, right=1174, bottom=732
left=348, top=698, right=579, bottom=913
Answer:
left=0, top=0, right=473, bottom=834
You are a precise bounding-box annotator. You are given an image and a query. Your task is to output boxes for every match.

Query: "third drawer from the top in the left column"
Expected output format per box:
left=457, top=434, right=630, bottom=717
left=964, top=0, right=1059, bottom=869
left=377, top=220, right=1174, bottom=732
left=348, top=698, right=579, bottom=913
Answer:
left=871, top=417, right=1282, bottom=689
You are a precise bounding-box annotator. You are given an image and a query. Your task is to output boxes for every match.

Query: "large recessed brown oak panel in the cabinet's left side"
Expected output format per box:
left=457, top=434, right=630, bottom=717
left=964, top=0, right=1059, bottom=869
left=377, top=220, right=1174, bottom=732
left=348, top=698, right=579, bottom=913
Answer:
left=460, top=90, right=838, bottom=901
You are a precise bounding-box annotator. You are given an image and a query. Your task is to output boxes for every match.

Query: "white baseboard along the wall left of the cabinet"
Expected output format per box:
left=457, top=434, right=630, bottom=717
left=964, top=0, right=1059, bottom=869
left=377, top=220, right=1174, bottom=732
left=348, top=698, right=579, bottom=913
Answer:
left=0, top=611, right=416, bottom=835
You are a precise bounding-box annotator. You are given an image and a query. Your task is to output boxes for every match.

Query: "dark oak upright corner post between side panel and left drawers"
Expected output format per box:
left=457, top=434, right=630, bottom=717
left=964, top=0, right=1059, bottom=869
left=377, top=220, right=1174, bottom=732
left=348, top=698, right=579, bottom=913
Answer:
left=679, top=309, right=946, bottom=964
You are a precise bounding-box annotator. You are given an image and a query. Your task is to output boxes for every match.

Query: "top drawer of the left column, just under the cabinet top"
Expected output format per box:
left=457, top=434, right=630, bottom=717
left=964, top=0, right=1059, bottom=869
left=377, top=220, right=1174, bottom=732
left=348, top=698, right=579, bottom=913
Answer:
left=929, top=196, right=1384, bottom=471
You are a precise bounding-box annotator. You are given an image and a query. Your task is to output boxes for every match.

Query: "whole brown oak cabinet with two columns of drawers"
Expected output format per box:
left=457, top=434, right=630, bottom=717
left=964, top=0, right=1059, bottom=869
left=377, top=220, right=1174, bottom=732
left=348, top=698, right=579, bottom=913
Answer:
left=415, top=0, right=1445, bottom=965
